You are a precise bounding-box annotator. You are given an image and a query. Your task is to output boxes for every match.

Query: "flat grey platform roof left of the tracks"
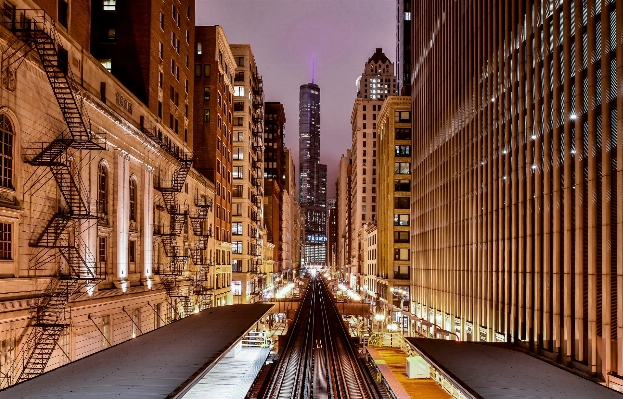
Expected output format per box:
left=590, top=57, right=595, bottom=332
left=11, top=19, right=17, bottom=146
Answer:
left=0, top=304, right=273, bottom=399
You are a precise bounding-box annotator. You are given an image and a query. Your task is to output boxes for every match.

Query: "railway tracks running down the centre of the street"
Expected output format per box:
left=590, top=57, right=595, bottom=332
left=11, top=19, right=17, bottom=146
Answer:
left=262, top=277, right=389, bottom=399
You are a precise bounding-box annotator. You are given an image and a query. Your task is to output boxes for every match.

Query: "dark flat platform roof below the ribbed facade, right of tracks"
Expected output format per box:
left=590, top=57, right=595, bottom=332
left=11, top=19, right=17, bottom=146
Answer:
left=407, top=338, right=623, bottom=399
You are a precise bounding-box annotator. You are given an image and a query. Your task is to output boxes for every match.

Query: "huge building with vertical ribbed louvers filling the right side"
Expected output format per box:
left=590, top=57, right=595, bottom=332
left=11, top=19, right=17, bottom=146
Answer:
left=410, top=0, right=623, bottom=387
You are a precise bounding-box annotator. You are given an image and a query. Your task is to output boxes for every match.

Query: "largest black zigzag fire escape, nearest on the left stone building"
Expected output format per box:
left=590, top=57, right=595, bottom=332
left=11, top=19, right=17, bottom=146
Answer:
left=2, top=10, right=106, bottom=387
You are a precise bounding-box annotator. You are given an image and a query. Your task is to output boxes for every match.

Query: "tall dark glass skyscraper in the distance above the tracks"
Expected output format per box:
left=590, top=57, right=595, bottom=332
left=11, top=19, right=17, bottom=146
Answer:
left=299, top=83, right=327, bottom=265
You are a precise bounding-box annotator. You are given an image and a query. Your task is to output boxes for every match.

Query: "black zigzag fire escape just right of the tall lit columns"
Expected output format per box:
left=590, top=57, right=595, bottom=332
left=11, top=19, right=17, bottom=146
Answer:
left=141, top=119, right=194, bottom=319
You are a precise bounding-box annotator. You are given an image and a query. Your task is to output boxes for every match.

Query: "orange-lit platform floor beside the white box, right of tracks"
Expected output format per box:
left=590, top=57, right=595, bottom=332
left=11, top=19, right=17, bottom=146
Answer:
left=366, top=347, right=452, bottom=399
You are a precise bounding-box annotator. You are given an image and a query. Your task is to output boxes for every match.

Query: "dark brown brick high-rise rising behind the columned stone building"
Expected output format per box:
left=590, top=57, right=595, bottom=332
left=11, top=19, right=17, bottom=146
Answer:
left=90, top=0, right=195, bottom=148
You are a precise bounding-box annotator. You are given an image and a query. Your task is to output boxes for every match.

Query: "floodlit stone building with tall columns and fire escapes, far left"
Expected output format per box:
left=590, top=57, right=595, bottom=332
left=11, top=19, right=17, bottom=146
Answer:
left=0, top=0, right=231, bottom=387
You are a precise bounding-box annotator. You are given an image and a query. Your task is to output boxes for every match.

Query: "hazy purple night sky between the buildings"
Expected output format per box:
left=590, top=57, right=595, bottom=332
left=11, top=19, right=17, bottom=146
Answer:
left=196, top=0, right=396, bottom=198
